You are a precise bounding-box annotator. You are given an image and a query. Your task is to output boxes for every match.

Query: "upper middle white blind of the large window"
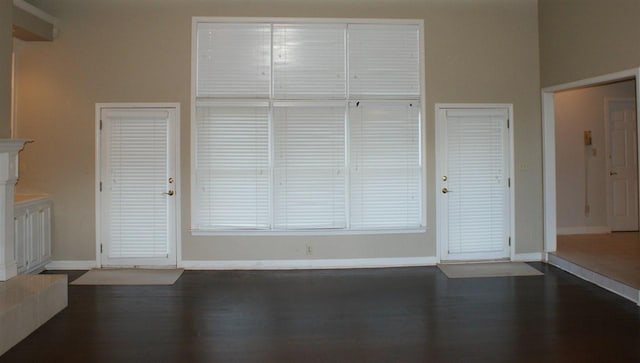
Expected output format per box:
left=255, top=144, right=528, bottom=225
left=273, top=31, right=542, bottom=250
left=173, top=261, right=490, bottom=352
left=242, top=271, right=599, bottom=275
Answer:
left=273, top=24, right=346, bottom=99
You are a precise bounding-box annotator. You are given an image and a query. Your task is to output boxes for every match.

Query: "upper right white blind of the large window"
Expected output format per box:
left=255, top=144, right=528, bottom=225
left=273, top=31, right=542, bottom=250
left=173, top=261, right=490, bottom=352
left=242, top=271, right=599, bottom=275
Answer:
left=349, top=24, right=420, bottom=98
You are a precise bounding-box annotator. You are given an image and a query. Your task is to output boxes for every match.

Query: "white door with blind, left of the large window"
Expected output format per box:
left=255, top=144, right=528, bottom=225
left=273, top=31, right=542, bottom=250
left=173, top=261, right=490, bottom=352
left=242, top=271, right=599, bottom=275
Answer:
left=99, top=108, right=177, bottom=266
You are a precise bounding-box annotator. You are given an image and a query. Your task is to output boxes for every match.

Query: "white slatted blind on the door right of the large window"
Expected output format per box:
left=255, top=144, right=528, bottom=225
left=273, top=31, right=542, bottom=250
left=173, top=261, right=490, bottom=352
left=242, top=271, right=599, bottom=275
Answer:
left=447, top=110, right=508, bottom=253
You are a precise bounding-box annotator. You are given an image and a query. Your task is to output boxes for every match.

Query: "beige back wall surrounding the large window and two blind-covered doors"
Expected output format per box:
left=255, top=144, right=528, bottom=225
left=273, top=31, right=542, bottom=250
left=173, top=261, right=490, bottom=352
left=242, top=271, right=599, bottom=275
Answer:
left=18, top=0, right=542, bottom=260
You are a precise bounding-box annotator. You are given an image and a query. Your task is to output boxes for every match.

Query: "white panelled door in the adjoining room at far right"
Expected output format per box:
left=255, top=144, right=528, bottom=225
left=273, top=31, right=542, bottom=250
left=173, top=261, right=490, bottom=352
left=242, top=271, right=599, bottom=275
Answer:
left=607, top=99, right=638, bottom=231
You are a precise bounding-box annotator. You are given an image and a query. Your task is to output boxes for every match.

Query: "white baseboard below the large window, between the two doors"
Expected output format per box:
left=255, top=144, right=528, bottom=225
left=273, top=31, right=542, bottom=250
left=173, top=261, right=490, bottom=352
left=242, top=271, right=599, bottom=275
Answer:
left=178, top=256, right=438, bottom=270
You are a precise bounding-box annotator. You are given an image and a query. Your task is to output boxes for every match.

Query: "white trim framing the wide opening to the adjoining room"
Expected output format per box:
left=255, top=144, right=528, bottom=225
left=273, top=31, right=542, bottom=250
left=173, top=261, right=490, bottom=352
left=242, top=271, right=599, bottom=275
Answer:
left=541, top=68, right=640, bottom=255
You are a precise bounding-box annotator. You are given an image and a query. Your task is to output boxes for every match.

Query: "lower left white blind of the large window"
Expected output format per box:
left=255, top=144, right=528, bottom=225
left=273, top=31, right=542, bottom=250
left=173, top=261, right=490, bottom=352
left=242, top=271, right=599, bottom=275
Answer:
left=193, top=103, right=271, bottom=229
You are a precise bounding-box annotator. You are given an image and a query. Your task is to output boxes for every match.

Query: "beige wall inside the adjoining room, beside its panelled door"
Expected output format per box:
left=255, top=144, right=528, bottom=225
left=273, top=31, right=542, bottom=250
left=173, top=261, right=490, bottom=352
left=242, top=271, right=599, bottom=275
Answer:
left=554, top=80, right=636, bottom=232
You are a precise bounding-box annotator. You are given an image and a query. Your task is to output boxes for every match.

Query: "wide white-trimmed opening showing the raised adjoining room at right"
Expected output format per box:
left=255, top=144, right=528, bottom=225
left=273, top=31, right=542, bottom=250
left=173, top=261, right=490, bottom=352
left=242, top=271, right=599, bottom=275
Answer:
left=542, top=69, right=640, bottom=301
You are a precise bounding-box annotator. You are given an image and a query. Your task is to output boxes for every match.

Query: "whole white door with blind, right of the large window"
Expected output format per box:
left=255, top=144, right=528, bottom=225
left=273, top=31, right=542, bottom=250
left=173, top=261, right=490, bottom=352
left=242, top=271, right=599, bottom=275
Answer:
left=436, top=107, right=511, bottom=261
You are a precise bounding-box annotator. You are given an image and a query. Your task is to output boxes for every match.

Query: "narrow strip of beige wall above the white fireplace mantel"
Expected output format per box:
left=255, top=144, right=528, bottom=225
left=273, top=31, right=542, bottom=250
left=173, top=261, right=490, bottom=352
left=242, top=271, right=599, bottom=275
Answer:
left=0, top=0, right=13, bottom=139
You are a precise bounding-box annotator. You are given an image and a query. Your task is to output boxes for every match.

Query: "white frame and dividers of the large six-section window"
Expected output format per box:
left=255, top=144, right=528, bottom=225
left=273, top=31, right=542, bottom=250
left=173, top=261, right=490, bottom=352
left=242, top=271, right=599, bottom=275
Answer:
left=189, top=17, right=429, bottom=236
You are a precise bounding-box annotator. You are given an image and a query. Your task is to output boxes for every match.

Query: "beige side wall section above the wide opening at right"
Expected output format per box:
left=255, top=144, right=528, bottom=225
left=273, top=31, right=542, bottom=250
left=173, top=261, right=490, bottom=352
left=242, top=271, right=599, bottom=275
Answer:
left=539, top=0, right=640, bottom=87
